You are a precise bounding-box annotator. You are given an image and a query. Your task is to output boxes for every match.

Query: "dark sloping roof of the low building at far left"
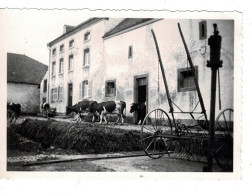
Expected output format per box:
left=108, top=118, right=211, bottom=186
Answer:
left=7, top=53, right=48, bottom=84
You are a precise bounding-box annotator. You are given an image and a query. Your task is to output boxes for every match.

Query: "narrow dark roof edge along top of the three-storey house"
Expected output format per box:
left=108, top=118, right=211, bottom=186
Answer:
left=47, top=18, right=106, bottom=47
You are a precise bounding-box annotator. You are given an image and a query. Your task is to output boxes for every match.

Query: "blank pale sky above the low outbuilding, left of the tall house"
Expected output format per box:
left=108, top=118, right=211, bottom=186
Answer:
left=0, top=10, right=89, bottom=65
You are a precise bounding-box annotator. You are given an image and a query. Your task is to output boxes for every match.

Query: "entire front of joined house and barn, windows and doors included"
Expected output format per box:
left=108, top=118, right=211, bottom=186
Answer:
left=49, top=18, right=234, bottom=121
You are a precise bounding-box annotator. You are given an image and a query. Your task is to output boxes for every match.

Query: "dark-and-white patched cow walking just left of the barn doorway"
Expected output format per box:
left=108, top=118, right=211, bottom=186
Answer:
left=89, top=101, right=126, bottom=124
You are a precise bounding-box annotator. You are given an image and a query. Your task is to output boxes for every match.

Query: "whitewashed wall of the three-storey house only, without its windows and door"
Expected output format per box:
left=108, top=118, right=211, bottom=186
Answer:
left=49, top=19, right=122, bottom=113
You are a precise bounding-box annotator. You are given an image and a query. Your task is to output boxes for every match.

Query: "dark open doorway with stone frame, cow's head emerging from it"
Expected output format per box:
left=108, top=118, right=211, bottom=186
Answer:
left=133, top=74, right=148, bottom=124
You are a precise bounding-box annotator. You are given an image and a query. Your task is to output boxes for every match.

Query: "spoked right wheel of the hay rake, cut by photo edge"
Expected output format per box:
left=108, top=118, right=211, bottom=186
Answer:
left=214, top=108, right=234, bottom=171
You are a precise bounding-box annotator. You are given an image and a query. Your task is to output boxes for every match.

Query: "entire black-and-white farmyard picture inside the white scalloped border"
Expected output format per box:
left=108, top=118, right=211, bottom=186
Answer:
left=2, top=10, right=240, bottom=173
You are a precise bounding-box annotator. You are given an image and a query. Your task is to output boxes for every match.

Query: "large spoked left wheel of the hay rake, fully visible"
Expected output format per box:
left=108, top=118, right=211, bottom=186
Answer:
left=141, top=109, right=172, bottom=159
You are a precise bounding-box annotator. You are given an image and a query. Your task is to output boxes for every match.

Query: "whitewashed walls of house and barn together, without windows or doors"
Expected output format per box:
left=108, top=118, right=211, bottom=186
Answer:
left=49, top=19, right=234, bottom=122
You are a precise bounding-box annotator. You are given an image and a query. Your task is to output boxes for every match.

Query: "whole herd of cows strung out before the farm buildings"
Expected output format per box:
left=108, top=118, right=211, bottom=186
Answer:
left=7, top=100, right=146, bottom=124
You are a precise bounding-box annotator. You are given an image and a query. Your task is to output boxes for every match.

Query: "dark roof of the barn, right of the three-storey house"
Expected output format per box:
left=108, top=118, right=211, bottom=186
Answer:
left=103, top=18, right=160, bottom=38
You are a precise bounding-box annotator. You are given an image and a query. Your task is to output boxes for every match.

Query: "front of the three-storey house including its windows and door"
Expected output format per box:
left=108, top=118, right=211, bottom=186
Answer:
left=48, top=18, right=122, bottom=114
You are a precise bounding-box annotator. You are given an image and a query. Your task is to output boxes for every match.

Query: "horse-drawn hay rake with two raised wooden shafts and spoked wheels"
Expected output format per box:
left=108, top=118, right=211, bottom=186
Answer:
left=141, top=24, right=233, bottom=171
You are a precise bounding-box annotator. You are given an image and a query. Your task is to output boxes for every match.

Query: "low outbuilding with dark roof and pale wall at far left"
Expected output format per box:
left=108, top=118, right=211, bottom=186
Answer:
left=7, top=53, right=48, bottom=114
